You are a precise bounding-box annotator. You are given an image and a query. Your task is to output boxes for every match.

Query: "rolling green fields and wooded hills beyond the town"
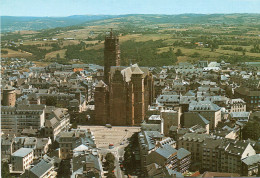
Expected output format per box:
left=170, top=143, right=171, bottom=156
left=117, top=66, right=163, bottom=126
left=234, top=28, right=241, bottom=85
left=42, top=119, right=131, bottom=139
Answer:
left=1, top=14, right=260, bottom=66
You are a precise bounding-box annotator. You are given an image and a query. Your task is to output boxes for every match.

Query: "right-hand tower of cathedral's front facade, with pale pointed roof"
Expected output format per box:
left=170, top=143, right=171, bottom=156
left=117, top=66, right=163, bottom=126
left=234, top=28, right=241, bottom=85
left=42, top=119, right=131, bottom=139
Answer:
left=131, top=66, right=145, bottom=125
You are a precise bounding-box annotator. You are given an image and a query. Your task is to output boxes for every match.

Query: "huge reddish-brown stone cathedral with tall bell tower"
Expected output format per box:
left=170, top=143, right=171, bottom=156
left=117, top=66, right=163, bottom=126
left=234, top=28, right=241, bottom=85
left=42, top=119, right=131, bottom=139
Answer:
left=94, top=30, right=154, bottom=126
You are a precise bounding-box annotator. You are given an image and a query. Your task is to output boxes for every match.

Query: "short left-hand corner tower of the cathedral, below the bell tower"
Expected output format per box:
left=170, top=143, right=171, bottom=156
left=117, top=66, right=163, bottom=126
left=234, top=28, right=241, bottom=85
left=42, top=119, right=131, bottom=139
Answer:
left=94, top=80, right=109, bottom=125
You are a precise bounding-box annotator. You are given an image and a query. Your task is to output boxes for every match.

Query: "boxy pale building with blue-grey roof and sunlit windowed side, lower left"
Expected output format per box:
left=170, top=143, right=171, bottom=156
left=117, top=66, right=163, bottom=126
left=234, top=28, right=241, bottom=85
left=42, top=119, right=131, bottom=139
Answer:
left=10, top=148, right=34, bottom=173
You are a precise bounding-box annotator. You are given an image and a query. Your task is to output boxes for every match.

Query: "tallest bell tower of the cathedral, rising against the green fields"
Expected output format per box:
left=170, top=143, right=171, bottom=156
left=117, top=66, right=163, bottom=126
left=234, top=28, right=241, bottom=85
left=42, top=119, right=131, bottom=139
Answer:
left=104, top=28, right=120, bottom=85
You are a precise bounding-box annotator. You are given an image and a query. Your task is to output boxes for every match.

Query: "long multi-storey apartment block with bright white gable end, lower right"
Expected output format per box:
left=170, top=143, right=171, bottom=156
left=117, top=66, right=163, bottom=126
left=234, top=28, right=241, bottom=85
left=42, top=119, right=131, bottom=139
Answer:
left=202, top=137, right=257, bottom=175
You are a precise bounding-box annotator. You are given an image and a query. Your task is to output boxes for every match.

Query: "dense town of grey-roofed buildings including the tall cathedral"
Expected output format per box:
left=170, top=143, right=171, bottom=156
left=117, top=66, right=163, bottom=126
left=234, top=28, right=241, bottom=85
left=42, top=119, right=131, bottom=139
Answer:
left=1, top=31, right=260, bottom=178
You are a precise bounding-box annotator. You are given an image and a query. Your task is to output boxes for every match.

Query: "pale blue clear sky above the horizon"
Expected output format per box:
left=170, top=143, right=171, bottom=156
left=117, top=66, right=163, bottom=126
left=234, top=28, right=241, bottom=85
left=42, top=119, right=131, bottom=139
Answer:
left=0, top=0, right=260, bottom=17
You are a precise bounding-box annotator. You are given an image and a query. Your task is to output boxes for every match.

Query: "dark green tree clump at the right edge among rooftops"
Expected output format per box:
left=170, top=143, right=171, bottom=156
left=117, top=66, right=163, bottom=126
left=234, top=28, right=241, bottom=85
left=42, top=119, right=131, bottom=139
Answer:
left=242, top=121, right=260, bottom=140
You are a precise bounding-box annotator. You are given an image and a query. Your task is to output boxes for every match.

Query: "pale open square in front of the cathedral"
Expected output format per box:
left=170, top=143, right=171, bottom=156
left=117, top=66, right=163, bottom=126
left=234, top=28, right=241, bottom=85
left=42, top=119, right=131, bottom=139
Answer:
left=78, top=126, right=140, bottom=148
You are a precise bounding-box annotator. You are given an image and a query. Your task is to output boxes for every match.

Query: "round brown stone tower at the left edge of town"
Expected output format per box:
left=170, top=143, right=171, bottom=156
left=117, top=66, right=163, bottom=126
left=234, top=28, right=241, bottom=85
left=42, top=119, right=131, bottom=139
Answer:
left=2, top=86, right=16, bottom=106
